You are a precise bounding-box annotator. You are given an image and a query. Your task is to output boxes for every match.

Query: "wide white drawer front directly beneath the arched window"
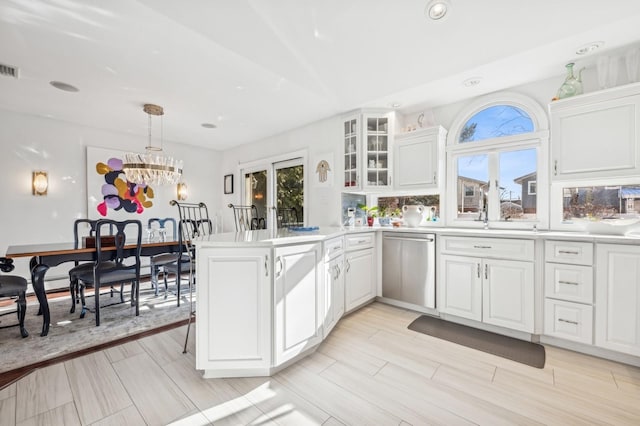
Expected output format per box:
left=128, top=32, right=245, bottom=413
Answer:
left=440, top=236, right=534, bottom=261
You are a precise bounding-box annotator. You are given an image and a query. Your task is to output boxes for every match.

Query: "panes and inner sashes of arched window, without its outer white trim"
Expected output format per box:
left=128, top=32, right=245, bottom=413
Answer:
left=452, top=101, right=539, bottom=225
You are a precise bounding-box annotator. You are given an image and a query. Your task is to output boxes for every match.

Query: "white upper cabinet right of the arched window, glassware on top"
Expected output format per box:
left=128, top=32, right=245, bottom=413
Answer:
left=549, top=84, right=640, bottom=181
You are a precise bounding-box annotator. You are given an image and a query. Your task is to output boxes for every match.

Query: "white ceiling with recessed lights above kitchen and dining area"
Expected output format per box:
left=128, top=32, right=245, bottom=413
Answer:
left=0, top=0, right=640, bottom=150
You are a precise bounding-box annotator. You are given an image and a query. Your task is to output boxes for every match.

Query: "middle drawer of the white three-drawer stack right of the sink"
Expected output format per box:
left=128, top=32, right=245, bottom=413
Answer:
left=544, top=262, right=593, bottom=303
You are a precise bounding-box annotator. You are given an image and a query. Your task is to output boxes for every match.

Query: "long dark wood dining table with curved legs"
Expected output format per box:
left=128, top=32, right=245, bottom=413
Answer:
left=5, top=238, right=183, bottom=336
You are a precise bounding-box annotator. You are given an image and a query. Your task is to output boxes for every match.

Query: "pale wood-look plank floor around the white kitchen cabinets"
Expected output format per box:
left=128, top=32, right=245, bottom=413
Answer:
left=0, top=303, right=640, bottom=426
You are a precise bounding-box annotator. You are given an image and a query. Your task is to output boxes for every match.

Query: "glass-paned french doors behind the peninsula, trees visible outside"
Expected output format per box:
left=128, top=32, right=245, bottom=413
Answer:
left=242, top=157, right=305, bottom=229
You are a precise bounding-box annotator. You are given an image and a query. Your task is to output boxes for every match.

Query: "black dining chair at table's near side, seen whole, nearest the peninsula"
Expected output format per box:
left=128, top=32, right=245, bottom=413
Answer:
left=78, top=219, right=142, bottom=326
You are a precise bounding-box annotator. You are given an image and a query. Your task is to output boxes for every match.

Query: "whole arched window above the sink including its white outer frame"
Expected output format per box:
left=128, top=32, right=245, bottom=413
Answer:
left=447, top=93, right=548, bottom=228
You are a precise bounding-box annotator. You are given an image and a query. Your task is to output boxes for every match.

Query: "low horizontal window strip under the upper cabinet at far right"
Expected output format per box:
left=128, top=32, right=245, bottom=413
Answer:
left=562, top=185, right=640, bottom=221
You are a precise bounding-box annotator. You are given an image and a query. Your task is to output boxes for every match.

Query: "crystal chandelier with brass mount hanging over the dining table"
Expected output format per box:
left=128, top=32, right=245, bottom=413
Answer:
left=122, top=104, right=182, bottom=185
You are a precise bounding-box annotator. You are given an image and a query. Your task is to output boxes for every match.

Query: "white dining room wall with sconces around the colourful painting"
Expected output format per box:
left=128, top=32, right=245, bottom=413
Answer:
left=0, top=110, right=222, bottom=277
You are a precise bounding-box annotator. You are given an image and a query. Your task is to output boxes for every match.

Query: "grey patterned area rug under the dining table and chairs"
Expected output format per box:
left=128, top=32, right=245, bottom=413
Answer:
left=0, top=284, right=195, bottom=374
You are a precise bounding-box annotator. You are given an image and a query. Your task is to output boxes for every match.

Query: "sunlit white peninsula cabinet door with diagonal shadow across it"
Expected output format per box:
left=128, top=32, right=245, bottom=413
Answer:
left=273, top=243, right=324, bottom=365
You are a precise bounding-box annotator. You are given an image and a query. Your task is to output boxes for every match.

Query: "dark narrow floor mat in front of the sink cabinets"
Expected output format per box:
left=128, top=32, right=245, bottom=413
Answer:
left=408, top=315, right=545, bottom=368
